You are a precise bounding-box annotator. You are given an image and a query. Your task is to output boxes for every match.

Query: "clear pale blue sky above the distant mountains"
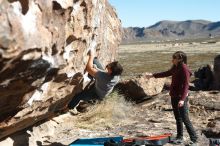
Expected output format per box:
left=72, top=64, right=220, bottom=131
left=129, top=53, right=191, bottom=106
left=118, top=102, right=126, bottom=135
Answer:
left=108, top=0, right=220, bottom=27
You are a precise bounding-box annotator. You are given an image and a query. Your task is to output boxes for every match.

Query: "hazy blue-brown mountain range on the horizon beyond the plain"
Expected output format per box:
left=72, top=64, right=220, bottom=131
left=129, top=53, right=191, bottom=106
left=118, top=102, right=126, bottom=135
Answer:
left=122, top=20, right=220, bottom=43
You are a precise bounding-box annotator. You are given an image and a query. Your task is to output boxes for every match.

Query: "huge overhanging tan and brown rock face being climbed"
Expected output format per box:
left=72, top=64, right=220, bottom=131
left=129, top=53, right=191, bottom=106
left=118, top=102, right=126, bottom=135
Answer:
left=0, top=0, right=121, bottom=139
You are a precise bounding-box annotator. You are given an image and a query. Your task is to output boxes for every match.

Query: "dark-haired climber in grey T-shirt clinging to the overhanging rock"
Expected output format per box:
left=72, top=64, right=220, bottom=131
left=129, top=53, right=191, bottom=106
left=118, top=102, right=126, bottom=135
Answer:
left=68, top=49, right=123, bottom=109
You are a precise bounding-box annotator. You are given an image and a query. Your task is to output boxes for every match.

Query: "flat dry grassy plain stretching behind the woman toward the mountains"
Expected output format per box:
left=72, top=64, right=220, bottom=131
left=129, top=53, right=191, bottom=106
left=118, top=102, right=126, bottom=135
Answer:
left=118, top=42, right=220, bottom=77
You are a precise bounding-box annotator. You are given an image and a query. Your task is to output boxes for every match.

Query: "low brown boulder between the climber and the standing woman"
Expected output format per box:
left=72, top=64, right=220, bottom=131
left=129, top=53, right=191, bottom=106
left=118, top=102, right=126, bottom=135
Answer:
left=116, top=74, right=165, bottom=102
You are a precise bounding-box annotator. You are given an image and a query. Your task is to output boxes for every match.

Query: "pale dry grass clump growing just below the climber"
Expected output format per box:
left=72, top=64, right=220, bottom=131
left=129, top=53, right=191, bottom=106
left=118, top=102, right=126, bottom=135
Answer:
left=75, top=92, right=132, bottom=130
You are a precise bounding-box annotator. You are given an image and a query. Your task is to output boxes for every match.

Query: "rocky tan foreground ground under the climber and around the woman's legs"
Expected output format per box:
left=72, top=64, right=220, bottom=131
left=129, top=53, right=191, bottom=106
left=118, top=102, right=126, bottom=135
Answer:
left=0, top=91, right=220, bottom=146
